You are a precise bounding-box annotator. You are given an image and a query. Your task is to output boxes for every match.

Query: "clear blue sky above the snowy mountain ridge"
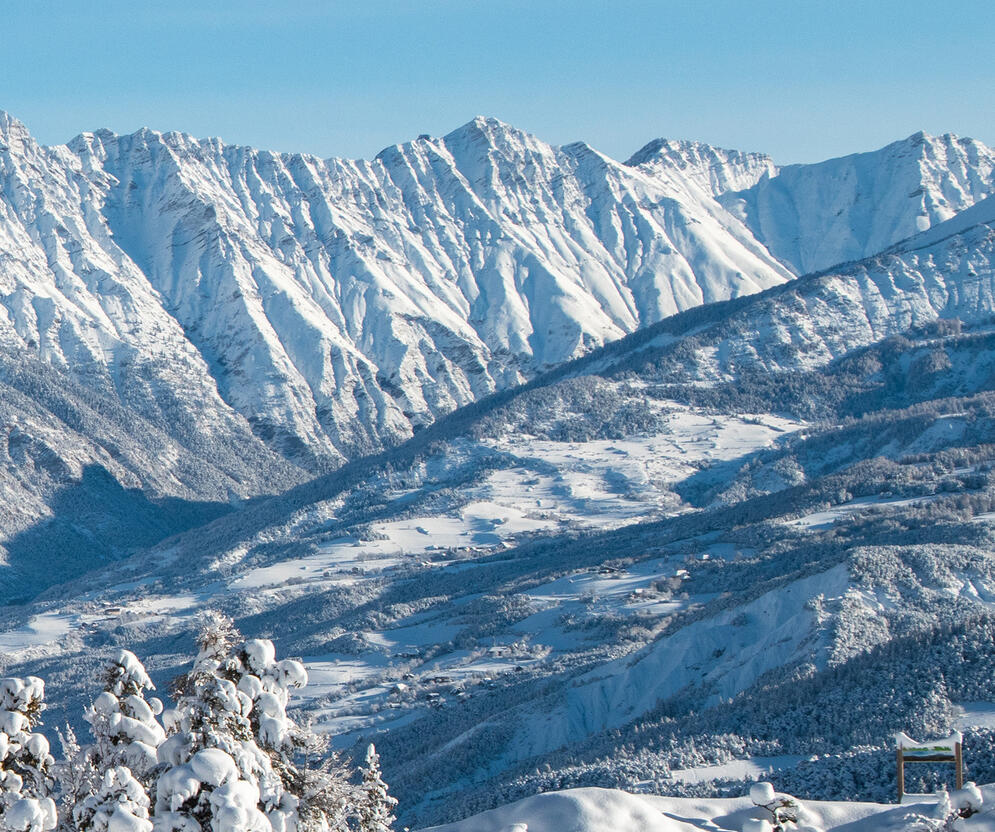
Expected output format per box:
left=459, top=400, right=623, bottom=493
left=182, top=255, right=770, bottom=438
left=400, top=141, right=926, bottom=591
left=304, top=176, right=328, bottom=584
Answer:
left=0, top=0, right=995, bottom=162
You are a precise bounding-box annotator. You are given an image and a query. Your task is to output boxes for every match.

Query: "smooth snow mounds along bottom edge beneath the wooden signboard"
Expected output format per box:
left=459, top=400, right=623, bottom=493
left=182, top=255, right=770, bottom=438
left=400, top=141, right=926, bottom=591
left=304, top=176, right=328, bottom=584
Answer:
left=424, top=786, right=995, bottom=832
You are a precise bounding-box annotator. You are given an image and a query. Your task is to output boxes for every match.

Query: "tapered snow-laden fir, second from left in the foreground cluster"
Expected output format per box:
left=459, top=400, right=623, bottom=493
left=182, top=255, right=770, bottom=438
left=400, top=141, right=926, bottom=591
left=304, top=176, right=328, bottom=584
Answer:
left=83, top=650, right=166, bottom=787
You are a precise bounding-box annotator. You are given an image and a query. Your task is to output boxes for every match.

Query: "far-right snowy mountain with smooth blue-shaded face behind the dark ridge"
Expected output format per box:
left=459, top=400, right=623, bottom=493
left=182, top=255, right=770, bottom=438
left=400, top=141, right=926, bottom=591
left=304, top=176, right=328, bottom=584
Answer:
left=720, top=133, right=995, bottom=274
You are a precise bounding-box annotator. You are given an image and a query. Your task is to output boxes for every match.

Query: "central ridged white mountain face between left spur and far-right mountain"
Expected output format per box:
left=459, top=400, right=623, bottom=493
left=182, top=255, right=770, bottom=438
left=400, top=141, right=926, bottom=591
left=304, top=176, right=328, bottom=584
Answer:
left=64, top=119, right=789, bottom=462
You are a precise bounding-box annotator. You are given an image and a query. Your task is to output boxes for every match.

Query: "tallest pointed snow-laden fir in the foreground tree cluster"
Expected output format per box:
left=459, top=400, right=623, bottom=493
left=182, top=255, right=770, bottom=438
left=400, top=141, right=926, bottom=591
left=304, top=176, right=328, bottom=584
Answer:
left=153, top=612, right=297, bottom=832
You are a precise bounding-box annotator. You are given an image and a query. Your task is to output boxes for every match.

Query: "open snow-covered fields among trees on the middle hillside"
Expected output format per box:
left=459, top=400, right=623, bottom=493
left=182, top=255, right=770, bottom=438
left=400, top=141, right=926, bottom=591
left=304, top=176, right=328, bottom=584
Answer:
left=0, top=406, right=801, bottom=744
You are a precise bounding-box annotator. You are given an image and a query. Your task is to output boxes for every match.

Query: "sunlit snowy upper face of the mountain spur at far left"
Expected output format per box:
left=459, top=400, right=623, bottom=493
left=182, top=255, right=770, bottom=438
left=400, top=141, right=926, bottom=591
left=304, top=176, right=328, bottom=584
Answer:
left=0, top=114, right=290, bottom=468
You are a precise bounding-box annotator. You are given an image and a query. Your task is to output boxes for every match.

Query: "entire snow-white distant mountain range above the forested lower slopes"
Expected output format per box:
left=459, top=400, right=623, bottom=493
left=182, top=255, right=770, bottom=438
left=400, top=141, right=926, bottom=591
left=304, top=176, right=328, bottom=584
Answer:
left=0, top=115, right=992, bottom=471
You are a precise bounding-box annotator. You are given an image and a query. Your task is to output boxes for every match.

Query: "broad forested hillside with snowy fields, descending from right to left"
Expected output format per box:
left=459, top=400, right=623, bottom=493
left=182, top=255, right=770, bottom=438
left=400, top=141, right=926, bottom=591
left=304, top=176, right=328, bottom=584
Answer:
left=4, top=193, right=995, bottom=825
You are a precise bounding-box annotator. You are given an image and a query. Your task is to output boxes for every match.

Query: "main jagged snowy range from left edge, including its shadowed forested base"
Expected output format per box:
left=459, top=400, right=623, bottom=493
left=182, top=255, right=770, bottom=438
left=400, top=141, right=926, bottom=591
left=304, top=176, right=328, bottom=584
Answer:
left=0, top=109, right=808, bottom=596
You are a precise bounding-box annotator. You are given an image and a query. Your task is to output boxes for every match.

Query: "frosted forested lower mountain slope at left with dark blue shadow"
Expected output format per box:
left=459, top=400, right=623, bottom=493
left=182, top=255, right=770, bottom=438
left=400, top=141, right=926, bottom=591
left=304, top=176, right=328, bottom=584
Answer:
left=0, top=346, right=302, bottom=602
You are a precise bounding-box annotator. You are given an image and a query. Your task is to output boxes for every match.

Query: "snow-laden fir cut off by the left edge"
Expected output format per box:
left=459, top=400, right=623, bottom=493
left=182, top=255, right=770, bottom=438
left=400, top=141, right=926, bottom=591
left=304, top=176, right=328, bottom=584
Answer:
left=0, top=676, right=58, bottom=832
